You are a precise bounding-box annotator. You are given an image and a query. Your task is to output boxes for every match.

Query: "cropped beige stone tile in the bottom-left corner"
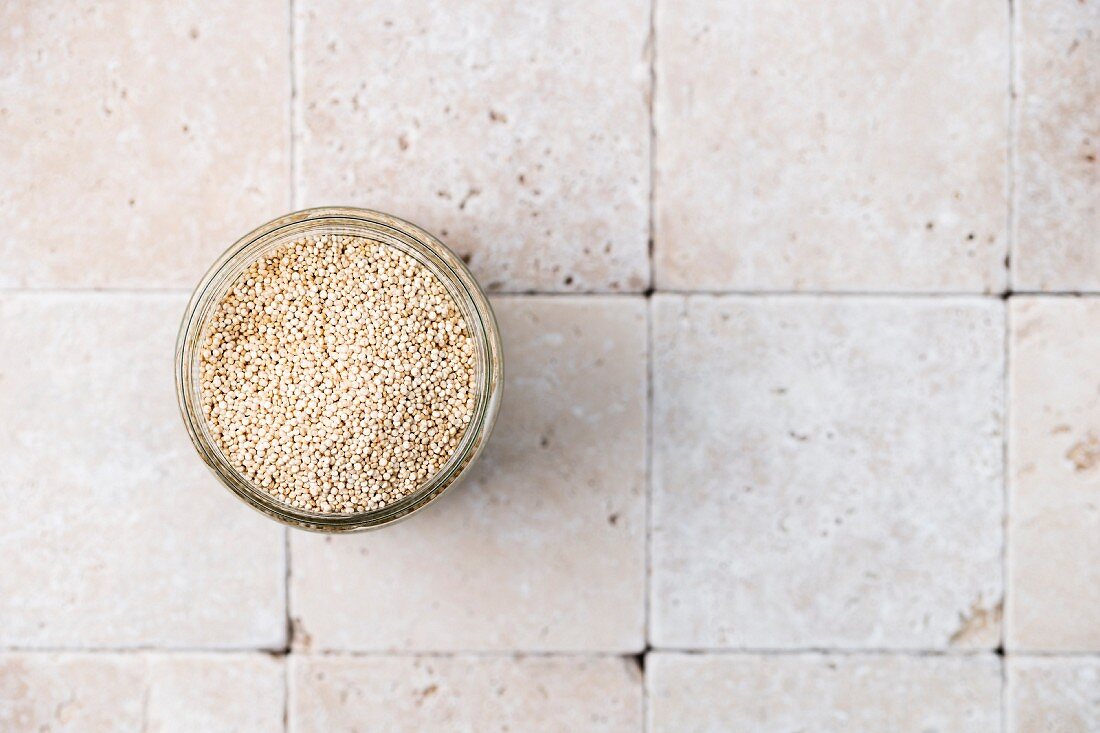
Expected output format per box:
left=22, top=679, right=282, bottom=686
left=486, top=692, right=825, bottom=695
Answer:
left=0, top=654, right=284, bottom=733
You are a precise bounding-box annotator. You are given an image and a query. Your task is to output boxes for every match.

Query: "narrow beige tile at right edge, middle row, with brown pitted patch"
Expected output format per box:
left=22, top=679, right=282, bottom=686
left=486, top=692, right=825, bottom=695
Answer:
left=1007, top=298, right=1100, bottom=652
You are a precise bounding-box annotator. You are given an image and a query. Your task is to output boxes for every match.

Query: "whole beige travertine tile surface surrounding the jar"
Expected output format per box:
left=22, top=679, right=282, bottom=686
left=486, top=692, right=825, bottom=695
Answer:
left=0, top=0, right=1100, bottom=733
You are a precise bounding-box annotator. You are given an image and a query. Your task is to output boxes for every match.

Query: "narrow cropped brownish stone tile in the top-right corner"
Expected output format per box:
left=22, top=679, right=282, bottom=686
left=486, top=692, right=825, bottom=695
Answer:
left=1012, top=0, right=1100, bottom=291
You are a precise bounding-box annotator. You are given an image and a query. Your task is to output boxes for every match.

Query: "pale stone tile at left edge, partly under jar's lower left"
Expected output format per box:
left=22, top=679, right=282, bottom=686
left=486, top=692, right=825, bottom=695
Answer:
left=0, top=294, right=286, bottom=648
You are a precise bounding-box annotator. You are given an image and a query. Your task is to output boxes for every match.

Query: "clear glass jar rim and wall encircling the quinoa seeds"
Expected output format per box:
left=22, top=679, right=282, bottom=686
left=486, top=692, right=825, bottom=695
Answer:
left=175, top=207, right=504, bottom=532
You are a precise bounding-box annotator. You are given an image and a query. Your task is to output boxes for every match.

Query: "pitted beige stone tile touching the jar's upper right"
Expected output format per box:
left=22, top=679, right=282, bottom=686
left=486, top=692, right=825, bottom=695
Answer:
left=295, top=0, right=649, bottom=292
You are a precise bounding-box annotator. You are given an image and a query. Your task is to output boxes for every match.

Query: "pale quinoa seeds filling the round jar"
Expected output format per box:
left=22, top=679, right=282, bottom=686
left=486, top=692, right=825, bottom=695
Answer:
left=200, top=234, right=475, bottom=514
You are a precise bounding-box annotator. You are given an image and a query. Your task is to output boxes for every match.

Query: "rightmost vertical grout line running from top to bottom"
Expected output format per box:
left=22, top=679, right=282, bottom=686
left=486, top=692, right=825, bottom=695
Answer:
left=1000, top=0, right=1019, bottom=733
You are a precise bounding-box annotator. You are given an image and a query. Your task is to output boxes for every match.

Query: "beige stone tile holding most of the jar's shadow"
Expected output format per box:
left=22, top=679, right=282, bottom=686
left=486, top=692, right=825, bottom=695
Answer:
left=290, top=296, right=646, bottom=652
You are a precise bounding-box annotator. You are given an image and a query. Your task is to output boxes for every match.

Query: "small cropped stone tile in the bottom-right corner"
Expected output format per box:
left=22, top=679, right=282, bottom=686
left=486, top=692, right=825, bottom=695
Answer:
left=1008, top=657, right=1100, bottom=733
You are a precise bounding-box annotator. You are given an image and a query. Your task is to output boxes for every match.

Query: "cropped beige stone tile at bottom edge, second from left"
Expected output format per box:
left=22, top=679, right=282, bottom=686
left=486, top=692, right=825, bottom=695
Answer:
left=289, top=656, right=642, bottom=733
